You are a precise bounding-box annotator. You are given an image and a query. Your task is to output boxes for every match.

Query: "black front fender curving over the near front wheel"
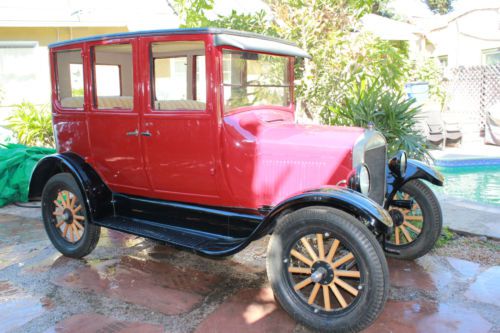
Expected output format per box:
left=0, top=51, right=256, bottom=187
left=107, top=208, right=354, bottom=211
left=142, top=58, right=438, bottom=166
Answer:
left=256, top=186, right=393, bottom=236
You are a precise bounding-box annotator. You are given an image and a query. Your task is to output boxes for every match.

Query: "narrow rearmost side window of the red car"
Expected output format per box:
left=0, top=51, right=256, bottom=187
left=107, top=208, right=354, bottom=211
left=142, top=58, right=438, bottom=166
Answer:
left=55, top=50, right=83, bottom=109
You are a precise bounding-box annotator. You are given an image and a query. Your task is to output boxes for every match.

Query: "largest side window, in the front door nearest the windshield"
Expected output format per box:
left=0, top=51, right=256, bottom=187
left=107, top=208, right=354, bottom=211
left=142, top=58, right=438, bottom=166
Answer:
left=151, top=42, right=207, bottom=111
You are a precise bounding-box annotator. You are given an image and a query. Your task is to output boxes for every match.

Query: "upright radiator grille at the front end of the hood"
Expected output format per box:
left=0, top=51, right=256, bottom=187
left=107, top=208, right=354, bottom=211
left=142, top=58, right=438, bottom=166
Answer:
left=365, top=146, right=386, bottom=205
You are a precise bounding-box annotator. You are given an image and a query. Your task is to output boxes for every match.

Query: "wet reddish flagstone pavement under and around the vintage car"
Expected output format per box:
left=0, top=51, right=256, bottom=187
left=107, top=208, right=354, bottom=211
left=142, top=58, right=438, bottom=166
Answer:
left=0, top=214, right=500, bottom=333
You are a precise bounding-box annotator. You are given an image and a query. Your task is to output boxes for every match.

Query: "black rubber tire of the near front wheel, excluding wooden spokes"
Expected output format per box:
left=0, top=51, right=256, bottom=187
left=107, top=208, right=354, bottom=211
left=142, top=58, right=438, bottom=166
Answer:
left=267, top=206, right=389, bottom=332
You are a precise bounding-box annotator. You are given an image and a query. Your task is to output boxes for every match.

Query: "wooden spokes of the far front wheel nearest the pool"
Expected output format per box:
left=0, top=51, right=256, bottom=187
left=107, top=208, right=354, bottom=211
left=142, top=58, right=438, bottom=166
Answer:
left=389, top=191, right=424, bottom=245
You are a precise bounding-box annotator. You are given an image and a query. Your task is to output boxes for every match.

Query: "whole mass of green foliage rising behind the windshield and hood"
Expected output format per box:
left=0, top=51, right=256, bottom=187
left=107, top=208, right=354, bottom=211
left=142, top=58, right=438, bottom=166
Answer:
left=173, top=0, right=437, bottom=158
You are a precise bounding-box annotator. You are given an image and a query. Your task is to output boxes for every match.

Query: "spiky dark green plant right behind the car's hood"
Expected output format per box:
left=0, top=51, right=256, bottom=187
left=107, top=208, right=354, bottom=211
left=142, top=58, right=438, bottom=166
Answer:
left=322, top=78, right=429, bottom=159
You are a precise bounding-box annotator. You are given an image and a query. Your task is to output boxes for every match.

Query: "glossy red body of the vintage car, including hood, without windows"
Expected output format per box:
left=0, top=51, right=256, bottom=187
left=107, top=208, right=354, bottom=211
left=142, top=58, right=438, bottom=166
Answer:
left=50, top=29, right=372, bottom=209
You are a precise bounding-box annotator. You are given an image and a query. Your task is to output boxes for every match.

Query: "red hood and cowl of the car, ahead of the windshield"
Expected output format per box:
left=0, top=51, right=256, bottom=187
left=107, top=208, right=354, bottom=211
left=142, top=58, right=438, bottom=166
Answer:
left=224, top=110, right=365, bottom=206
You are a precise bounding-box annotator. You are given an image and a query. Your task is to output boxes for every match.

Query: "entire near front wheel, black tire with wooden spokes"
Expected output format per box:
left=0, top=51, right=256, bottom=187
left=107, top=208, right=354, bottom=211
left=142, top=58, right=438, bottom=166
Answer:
left=267, top=206, right=389, bottom=332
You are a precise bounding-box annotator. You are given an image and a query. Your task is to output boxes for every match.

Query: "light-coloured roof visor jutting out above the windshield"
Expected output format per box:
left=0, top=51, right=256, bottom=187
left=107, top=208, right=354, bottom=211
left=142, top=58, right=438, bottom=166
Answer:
left=214, top=34, right=311, bottom=59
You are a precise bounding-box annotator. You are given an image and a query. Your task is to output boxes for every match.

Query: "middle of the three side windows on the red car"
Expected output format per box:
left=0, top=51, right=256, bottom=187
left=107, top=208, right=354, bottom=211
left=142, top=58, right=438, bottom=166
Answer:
left=92, top=44, right=134, bottom=110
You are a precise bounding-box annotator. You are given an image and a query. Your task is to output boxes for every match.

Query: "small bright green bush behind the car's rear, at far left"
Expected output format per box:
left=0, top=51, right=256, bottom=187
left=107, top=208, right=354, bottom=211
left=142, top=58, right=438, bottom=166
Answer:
left=6, top=102, right=54, bottom=147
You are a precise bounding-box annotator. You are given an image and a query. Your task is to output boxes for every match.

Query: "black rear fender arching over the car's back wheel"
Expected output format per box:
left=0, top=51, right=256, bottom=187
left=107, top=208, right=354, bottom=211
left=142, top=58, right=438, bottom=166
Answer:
left=29, top=152, right=113, bottom=221
